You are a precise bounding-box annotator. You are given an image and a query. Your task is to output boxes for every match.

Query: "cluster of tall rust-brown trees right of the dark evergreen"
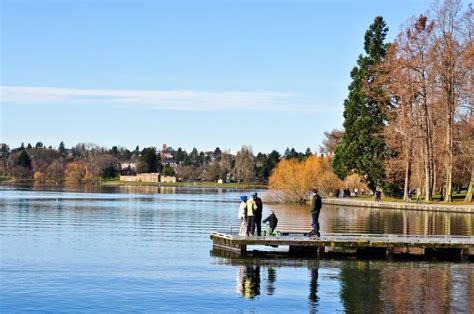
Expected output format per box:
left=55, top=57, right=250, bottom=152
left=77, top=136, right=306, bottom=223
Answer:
left=382, top=0, right=473, bottom=201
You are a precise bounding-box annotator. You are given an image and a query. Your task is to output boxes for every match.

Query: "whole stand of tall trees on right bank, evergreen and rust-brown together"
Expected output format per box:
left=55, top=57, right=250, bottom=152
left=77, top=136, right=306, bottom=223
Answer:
left=332, top=0, right=474, bottom=201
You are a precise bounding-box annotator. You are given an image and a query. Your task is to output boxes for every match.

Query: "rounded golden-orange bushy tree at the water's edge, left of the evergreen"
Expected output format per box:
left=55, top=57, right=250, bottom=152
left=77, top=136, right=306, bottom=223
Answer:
left=269, top=155, right=342, bottom=203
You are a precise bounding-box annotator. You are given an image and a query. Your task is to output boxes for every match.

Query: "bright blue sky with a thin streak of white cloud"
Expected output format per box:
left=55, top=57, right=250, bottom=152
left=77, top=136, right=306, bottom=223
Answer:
left=0, top=0, right=431, bottom=153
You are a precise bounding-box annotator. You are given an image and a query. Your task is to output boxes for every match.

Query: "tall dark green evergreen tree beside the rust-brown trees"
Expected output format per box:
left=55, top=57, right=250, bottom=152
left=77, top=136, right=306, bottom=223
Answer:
left=333, top=16, right=388, bottom=190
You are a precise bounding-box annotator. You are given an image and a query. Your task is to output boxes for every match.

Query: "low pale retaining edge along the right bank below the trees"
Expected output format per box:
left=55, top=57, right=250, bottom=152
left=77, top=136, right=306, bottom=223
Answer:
left=322, top=198, right=474, bottom=214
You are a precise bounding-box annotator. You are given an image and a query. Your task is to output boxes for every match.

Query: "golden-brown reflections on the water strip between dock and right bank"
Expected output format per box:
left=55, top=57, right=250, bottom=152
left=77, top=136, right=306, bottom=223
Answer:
left=264, top=205, right=474, bottom=235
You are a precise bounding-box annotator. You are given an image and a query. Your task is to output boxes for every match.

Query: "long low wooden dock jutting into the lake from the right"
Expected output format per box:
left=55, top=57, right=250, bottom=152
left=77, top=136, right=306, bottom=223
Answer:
left=211, top=232, right=474, bottom=259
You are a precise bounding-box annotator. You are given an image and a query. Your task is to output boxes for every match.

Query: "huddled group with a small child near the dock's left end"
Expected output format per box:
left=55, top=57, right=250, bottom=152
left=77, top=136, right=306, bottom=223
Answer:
left=239, top=193, right=278, bottom=236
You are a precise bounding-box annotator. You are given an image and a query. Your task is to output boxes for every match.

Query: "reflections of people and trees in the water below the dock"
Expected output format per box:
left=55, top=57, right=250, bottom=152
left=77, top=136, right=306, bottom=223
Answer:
left=219, top=253, right=474, bottom=313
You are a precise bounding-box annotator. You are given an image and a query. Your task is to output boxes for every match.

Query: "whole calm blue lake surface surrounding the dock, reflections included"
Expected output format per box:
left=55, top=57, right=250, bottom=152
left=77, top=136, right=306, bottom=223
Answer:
left=0, top=186, right=474, bottom=313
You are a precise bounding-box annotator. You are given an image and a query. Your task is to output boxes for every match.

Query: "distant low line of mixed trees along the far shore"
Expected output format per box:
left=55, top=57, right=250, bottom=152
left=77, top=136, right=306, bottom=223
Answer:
left=0, top=142, right=311, bottom=183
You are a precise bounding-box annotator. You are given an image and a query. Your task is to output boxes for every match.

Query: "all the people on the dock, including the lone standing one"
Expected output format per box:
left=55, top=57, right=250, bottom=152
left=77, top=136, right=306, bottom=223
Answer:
left=239, top=189, right=322, bottom=237
